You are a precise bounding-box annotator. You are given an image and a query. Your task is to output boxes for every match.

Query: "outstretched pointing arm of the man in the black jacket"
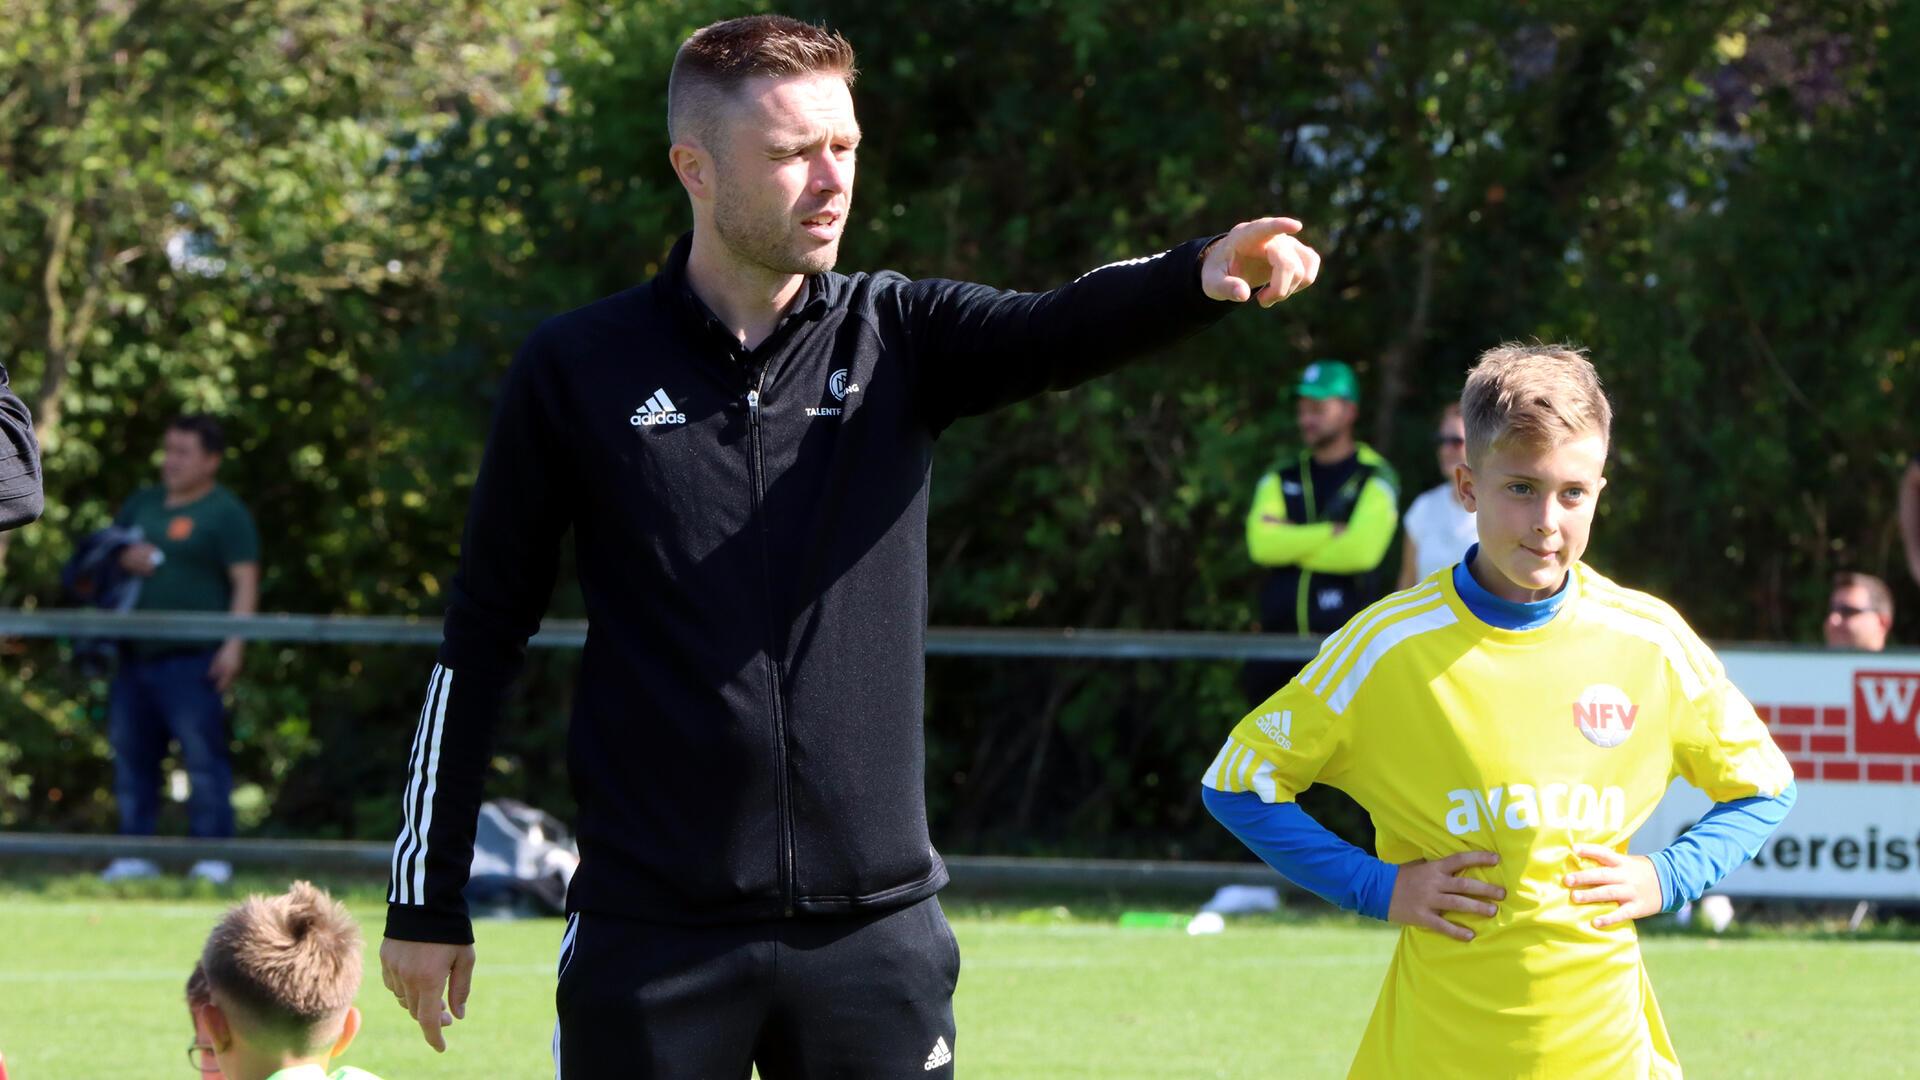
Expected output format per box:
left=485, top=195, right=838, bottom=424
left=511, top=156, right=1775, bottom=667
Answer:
left=904, top=217, right=1319, bottom=429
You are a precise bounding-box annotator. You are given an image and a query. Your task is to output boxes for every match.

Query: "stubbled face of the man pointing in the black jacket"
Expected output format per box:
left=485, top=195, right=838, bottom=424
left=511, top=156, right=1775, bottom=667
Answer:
left=714, top=75, right=860, bottom=275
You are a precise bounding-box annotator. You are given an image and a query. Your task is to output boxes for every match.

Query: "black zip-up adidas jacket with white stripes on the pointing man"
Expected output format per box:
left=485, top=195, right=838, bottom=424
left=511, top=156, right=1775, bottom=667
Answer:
left=386, top=238, right=1231, bottom=944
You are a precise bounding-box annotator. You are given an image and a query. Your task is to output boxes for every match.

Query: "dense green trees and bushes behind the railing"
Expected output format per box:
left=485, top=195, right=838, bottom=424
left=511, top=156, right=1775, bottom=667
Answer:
left=0, top=0, right=1920, bottom=855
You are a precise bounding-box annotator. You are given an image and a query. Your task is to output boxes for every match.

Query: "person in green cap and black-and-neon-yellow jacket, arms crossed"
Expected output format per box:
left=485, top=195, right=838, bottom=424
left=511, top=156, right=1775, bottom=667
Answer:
left=1246, top=359, right=1400, bottom=701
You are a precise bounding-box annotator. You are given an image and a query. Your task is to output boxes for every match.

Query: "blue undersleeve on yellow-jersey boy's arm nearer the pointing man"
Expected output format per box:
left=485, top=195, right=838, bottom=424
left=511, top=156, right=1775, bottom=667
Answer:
left=1200, top=788, right=1400, bottom=920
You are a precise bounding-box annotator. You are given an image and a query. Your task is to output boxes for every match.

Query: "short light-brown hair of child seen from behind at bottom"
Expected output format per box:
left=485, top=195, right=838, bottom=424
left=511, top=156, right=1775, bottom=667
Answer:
left=200, top=882, right=361, bottom=1049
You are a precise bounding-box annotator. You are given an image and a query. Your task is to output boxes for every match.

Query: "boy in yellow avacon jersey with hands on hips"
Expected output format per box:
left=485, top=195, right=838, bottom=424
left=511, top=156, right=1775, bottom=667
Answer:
left=1202, top=346, right=1793, bottom=1080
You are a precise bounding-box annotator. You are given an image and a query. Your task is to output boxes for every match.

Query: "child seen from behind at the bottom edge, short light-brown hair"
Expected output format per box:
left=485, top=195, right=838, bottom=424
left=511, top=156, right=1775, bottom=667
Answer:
left=199, top=882, right=376, bottom=1080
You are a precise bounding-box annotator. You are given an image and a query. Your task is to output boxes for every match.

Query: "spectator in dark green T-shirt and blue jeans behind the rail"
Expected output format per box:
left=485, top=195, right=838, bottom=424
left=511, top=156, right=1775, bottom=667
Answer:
left=104, top=415, right=259, bottom=882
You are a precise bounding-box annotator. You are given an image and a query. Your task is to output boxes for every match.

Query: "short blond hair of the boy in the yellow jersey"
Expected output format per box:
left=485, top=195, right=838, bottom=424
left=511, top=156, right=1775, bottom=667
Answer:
left=1459, top=342, right=1613, bottom=461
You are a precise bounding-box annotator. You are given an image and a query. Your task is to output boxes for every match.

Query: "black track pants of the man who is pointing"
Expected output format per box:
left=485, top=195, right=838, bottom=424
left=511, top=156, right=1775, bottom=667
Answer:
left=553, top=897, right=960, bottom=1080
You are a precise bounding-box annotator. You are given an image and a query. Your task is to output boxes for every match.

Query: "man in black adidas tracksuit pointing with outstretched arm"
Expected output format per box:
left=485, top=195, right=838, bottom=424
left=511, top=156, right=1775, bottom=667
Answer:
left=382, top=15, right=1319, bottom=1080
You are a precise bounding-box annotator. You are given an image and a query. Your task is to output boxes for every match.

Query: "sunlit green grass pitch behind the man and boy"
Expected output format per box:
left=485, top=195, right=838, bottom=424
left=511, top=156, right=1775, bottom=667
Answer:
left=0, top=892, right=1920, bottom=1080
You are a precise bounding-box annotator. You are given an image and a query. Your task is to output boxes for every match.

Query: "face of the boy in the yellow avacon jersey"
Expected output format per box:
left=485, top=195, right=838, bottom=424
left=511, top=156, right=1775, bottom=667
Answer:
left=1455, top=434, right=1607, bottom=600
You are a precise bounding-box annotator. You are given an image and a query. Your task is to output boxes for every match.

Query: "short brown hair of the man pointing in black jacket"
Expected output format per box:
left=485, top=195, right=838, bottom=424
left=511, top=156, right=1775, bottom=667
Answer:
left=666, top=15, right=858, bottom=148
